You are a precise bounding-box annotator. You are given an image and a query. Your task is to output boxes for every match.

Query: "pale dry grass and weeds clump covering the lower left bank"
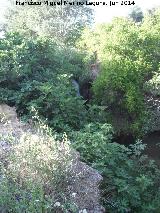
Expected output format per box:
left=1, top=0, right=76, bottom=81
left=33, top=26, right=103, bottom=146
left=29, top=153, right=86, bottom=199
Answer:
left=0, top=122, right=76, bottom=213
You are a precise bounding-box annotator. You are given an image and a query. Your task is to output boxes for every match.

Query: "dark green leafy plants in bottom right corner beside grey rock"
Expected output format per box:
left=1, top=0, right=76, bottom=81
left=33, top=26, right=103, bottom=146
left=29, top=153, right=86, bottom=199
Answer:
left=101, top=142, right=160, bottom=212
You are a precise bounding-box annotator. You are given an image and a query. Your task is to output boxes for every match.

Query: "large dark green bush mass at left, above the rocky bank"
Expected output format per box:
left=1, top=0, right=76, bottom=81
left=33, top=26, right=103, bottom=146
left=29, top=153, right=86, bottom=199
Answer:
left=0, top=33, right=87, bottom=131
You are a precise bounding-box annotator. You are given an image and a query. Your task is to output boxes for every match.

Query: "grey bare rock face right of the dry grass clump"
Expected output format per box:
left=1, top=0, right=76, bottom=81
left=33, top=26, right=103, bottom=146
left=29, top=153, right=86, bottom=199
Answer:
left=69, top=153, right=104, bottom=213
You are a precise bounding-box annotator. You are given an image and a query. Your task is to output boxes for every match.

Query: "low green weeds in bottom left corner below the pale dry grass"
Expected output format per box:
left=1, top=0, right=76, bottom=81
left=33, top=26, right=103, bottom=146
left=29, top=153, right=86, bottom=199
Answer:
left=0, top=177, right=52, bottom=213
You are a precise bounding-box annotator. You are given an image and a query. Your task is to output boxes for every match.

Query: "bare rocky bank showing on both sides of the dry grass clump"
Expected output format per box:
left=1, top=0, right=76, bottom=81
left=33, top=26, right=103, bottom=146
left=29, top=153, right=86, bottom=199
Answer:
left=0, top=104, right=104, bottom=213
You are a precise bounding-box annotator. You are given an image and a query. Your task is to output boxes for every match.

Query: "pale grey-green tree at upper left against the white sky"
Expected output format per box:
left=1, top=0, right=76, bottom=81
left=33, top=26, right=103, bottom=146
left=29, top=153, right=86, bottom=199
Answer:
left=5, top=0, right=93, bottom=43
